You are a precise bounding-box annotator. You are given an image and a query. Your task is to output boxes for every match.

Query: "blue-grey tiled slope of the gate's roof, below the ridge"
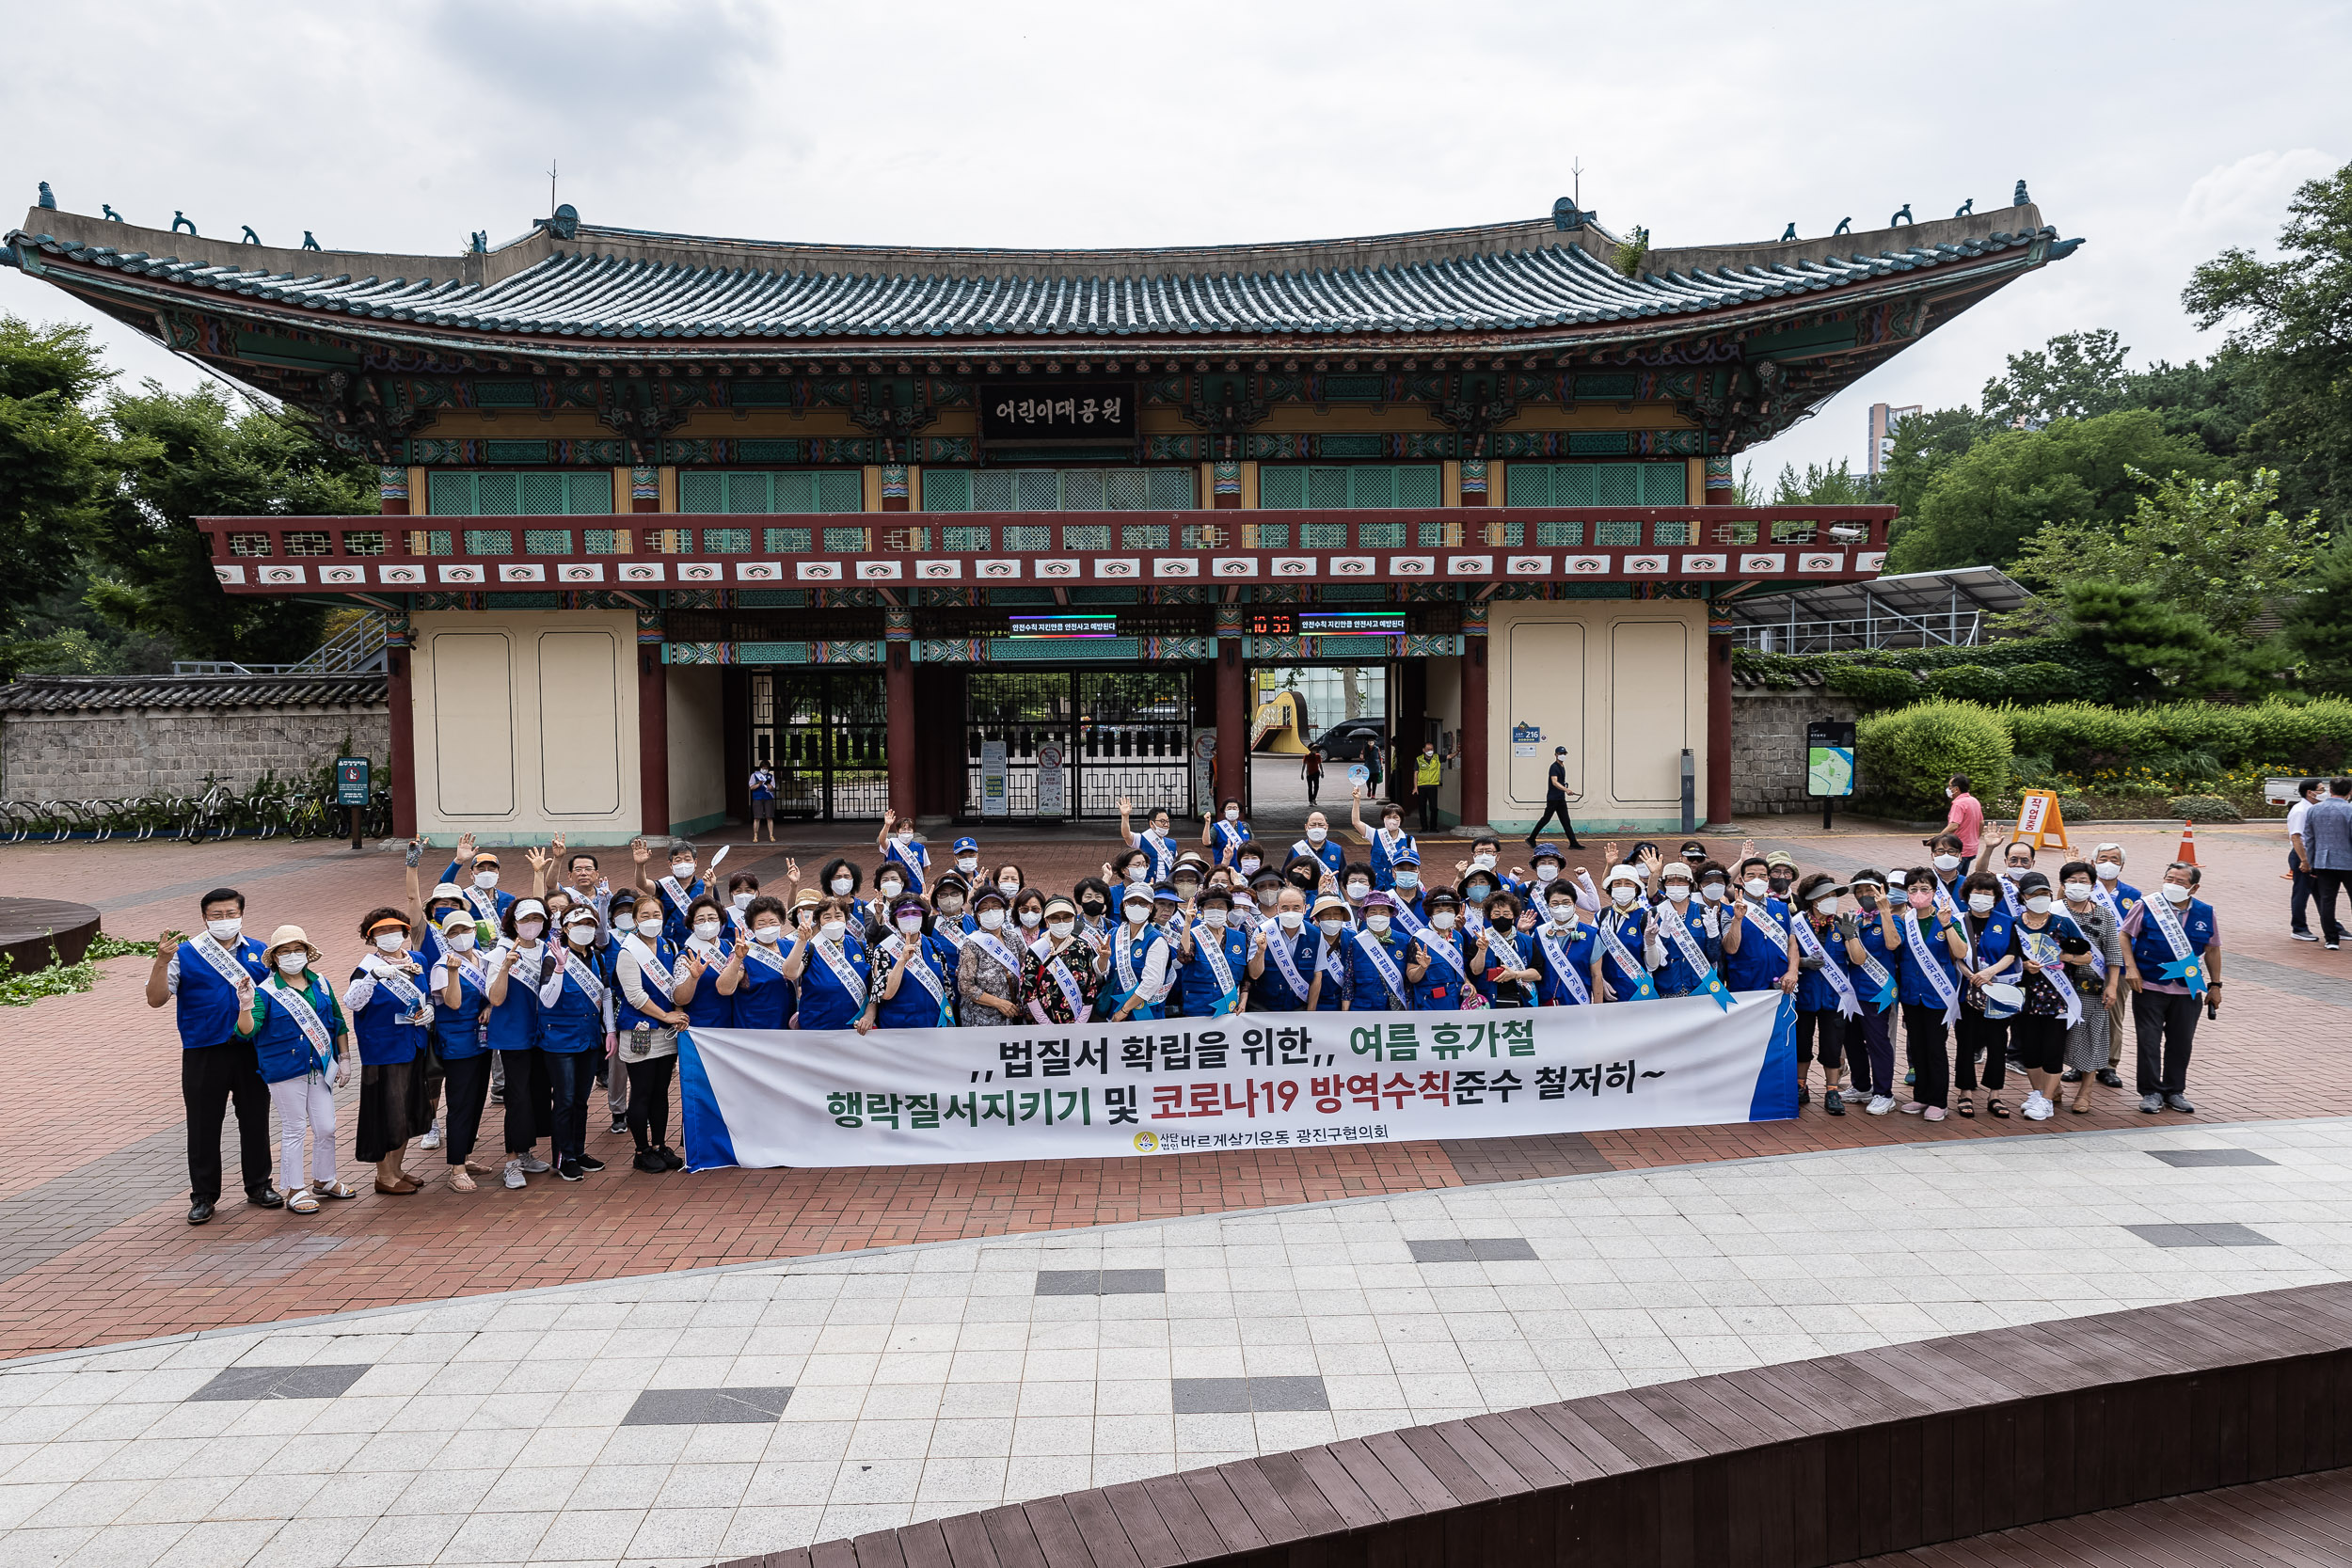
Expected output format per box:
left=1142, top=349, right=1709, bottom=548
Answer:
left=9, top=226, right=2079, bottom=341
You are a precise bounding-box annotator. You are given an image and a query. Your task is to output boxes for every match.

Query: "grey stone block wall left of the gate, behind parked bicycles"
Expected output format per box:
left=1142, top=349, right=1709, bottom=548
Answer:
left=0, top=703, right=393, bottom=801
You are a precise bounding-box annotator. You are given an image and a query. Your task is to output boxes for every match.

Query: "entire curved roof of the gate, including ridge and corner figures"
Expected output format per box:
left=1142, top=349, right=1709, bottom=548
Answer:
left=0, top=204, right=2079, bottom=357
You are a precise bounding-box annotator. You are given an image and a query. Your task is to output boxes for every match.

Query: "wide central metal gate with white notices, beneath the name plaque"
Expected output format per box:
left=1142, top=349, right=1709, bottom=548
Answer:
left=964, top=668, right=1198, bottom=820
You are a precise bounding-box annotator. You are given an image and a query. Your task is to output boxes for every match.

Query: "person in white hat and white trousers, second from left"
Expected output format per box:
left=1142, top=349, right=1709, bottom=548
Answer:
left=235, top=927, right=360, bottom=1213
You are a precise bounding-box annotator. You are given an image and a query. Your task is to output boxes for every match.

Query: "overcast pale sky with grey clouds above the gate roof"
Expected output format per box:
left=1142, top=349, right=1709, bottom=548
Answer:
left=0, top=0, right=2352, bottom=477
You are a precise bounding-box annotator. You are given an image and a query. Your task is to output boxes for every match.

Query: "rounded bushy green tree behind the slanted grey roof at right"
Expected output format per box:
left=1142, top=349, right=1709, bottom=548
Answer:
left=1886, top=409, right=2218, bottom=571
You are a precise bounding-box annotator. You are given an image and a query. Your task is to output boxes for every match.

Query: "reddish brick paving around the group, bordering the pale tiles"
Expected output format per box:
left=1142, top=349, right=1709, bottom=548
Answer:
left=0, top=818, right=2352, bottom=1356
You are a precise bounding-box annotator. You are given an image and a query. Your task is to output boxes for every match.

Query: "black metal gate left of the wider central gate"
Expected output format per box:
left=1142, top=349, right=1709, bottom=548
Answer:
left=751, top=670, right=889, bottom=823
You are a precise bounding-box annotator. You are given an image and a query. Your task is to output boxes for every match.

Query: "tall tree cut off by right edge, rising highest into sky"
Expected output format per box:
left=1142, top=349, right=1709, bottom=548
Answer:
left=2181, top=165, right=2352, bottom=519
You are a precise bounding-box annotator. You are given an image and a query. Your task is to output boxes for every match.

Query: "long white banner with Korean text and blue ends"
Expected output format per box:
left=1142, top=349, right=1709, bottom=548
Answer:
left=677, top=992, right=1797, bottom=1171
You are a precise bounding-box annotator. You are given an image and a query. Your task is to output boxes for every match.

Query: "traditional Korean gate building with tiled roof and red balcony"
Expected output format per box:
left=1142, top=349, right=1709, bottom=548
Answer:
left=5, top=183, right=2079, bottom=842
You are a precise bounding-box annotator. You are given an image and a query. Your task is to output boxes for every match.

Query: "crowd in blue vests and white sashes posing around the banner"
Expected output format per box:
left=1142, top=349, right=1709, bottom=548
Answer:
left=149, top=781, right=2220, bottom=1225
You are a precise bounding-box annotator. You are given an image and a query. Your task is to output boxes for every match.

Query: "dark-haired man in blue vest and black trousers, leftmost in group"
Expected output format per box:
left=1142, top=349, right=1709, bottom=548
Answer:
left=146, top=889, right=285, bottom=1225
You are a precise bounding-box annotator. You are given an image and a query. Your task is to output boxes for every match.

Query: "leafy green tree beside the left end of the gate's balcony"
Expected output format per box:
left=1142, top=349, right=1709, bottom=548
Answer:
left=89, top=392, right=376, bottom=663
